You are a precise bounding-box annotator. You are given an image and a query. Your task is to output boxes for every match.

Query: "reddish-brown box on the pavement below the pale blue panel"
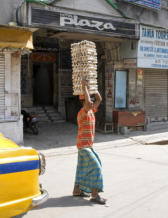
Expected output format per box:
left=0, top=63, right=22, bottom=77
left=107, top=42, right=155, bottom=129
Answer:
left=113, top=111, right=145, bottom=129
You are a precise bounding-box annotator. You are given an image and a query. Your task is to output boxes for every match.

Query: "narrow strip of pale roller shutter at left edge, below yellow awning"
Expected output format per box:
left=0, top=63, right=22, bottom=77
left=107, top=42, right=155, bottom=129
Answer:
left=0, top=54, right=5, bottom=119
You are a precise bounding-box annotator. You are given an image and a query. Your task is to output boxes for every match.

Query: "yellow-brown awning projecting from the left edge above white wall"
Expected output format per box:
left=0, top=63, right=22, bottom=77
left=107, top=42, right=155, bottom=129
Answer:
left=0, top=27, right=33, bottom=49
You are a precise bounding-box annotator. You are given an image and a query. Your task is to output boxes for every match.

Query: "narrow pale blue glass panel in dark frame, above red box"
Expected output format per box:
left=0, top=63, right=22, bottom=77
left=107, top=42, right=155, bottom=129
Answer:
left=115, top=70, right=127, bottom=109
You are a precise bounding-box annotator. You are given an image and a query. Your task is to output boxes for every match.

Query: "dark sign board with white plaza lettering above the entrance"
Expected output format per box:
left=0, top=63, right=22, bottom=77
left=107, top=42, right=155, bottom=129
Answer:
left=31, top=8, right=138, bottom=38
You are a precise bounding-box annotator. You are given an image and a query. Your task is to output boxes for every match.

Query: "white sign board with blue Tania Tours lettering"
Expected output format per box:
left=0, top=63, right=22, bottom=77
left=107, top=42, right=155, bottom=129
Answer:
left=137, top=25, right=168, bottom=69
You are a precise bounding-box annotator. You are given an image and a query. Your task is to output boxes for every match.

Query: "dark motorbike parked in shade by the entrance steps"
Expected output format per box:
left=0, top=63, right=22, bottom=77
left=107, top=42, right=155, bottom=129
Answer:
left=21, top=110, right=39, bottom=135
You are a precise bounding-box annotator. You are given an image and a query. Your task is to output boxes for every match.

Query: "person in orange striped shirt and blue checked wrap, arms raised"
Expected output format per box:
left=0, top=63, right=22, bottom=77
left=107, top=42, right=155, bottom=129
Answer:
left=73, top=80, right=106, bottom=204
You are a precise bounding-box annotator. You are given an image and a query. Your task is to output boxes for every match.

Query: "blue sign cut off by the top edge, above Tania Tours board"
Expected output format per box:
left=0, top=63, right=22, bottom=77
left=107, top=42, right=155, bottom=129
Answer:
left=128, top=0, right=161, bottom=10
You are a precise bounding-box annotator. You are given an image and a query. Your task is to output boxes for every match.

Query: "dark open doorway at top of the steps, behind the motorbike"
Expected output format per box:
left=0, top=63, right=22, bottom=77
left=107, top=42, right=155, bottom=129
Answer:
left=33, top=63, right=53, bottom=105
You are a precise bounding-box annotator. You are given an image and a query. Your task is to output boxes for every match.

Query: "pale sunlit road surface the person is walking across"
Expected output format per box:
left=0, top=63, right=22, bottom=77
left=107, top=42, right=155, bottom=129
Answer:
left=23, top=139, right=168, bottom=218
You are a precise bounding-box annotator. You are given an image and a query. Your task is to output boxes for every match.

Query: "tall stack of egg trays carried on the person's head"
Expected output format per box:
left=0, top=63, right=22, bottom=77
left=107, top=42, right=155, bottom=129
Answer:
left=71, top=40, right=98, bottom=95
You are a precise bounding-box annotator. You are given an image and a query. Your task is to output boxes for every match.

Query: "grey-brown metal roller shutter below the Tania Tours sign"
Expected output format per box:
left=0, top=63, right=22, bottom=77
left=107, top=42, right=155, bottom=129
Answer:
left=144, top=69, right=168, bottom=121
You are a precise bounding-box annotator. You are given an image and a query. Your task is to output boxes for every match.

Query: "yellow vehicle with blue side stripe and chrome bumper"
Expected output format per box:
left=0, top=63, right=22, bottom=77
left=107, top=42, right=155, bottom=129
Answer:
left=0, top=134, right=48, bottom=218
